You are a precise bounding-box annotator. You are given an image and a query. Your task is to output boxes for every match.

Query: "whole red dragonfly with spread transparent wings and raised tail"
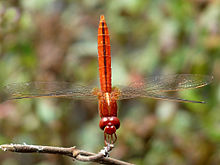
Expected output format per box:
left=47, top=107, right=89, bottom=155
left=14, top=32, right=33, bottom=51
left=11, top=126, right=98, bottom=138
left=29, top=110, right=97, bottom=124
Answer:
left=2, top=15, right=213, bottom=145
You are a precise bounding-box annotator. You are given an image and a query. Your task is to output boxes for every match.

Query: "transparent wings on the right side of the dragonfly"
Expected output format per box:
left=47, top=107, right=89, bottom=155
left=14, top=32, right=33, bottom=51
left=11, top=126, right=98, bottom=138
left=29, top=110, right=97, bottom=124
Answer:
left=119, top=74, right=213, bottom=103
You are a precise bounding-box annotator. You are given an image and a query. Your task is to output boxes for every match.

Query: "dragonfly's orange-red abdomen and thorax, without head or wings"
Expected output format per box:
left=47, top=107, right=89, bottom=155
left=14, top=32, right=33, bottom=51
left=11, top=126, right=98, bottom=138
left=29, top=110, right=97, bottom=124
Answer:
left=98, top=15, right=117, bottom=118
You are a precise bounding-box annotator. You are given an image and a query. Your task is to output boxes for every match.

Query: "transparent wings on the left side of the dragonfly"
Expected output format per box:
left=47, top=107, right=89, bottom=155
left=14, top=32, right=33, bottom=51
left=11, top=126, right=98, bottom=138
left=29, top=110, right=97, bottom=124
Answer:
left=0, top=82, right=97, bottom=102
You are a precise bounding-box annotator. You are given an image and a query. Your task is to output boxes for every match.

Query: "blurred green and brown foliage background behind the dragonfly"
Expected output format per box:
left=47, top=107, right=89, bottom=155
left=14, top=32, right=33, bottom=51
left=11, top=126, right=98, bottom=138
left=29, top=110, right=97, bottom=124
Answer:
left=0, top=0, right=220, bottom=165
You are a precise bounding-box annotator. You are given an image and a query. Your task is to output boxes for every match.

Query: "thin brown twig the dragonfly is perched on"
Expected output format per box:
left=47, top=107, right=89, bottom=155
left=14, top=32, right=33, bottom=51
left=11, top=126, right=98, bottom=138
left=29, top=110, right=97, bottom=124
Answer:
left=0, top=144, right=132, bottom=165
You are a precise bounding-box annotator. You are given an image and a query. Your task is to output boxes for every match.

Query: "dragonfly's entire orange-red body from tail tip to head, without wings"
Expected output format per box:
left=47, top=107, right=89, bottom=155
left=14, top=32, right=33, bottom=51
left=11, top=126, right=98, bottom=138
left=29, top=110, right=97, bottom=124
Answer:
left=98, top=15, right=120, bottom=144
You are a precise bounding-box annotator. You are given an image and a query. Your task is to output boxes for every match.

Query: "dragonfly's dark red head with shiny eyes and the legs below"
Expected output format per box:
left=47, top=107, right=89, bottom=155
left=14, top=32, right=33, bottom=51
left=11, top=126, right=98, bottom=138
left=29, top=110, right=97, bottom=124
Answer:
left=99, top=116, right=120, bottom=145
